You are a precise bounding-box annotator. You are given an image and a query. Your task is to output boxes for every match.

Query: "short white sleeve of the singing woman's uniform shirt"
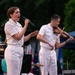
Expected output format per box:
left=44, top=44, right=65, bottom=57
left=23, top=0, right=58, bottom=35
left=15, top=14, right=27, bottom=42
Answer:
left=5, top=23, right=18, bottom=36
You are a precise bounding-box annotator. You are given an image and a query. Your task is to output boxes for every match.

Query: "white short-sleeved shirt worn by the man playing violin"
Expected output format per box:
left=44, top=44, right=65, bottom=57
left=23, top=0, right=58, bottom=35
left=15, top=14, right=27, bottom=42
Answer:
left=39, top=23, right=59, bottom=49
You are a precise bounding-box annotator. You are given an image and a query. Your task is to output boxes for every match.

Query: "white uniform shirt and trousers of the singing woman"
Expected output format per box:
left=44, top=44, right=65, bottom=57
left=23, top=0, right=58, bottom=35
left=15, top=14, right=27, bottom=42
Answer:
left=4, top=19, right=24, bottom=75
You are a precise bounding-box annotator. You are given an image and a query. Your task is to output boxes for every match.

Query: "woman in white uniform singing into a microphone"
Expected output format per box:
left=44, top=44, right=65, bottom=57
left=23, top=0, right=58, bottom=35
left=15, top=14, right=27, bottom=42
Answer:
left=4, top=7, right=38, bottom=75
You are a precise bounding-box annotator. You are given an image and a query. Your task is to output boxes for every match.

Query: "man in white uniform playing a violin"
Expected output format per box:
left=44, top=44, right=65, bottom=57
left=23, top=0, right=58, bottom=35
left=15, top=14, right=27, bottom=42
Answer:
left=37, top=14, right=73, bottom=75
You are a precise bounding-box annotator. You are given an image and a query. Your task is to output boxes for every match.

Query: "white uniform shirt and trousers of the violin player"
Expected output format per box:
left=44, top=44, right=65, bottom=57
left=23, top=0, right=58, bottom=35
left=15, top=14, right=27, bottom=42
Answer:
left=39, top=24, right=59, bottom=75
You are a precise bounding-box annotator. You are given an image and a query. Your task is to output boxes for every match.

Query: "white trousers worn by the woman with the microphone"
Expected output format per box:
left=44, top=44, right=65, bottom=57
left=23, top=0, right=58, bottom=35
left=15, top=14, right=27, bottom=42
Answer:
left=5, top=46, right=23, bottom=75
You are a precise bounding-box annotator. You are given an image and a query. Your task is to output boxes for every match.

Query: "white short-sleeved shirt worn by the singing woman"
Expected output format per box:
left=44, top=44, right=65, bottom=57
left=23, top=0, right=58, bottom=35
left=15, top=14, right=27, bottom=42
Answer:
left=4, top=19, right=24, bottom=46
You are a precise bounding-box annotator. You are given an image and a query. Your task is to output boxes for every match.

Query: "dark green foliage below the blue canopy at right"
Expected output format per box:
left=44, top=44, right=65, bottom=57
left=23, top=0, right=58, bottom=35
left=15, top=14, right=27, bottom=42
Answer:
left=63, top=49, right=75, bottom=69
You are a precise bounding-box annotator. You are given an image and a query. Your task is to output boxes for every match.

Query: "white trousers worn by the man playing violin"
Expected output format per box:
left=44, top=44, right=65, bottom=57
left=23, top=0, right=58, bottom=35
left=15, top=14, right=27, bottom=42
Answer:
left=39, top=47, right=57, bottom=75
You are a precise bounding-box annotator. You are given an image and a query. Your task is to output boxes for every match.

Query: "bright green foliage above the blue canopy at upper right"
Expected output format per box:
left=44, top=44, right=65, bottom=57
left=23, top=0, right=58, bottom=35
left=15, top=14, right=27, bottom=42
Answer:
left=64, top=0, right=75, bottom=32
